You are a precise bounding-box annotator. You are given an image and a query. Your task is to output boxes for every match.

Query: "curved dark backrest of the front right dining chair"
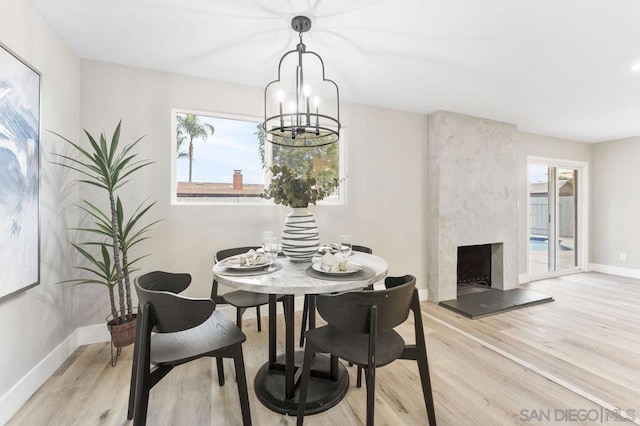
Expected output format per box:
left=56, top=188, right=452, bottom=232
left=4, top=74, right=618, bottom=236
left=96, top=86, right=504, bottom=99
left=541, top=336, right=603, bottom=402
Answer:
left=316, top=275, right=416, bottom=334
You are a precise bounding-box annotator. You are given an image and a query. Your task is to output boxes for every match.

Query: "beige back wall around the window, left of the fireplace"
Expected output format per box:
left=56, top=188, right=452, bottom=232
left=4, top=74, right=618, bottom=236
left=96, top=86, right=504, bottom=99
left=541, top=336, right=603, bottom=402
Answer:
left=80, top=60, right=426, bottom=296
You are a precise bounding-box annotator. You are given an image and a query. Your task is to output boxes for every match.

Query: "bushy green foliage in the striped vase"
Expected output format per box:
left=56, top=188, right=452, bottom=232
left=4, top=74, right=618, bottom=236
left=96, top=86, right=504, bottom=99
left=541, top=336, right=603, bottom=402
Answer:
left=260, top=165, right=338, bottom=208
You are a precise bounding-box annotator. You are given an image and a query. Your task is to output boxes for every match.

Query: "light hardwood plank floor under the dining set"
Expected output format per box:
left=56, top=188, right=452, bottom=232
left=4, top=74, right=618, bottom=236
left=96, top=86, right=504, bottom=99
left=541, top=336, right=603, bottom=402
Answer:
left=9, top=273, right=640, bottom=426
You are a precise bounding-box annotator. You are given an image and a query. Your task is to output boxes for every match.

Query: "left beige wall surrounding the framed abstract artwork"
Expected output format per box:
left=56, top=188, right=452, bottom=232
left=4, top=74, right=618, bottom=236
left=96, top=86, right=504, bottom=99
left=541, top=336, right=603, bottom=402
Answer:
left=0, top=0, right=85, bottom=414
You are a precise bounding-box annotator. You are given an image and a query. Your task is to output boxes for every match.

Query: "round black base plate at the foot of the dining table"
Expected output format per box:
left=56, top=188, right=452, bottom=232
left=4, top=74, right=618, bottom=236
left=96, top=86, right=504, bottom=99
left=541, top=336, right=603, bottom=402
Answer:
left=254, top=351, right=349, bottom=416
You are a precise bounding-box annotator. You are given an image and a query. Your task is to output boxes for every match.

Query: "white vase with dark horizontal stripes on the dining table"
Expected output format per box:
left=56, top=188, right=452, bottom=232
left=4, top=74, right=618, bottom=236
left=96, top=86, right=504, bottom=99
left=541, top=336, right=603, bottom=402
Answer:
left=281, top=208, right=320, bottom=262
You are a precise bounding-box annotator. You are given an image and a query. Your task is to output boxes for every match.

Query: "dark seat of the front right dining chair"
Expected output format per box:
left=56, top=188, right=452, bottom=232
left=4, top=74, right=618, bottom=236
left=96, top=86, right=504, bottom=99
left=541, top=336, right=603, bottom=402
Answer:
left=305, top=325, right=405, bottom=367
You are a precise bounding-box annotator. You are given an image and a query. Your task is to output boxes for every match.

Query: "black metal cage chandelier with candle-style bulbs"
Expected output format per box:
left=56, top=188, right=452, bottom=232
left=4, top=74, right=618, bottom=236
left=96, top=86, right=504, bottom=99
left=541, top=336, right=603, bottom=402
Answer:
left=262, top=16, right=340, bottom=147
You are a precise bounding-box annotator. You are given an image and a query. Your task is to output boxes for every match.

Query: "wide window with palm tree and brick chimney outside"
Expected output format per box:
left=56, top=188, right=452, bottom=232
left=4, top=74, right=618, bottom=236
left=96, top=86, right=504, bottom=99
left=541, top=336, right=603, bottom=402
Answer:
left=172, top=110, right=344, bottom=204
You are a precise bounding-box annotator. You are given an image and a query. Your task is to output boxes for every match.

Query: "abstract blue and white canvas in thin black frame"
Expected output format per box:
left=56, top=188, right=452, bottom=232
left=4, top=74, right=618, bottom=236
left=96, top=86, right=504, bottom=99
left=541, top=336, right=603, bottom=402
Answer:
left=0, top=43, right=40, bottom=299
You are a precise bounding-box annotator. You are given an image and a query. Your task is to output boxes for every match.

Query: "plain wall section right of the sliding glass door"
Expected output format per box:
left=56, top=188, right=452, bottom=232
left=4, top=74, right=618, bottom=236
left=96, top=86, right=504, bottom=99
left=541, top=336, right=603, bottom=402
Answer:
left=591, top=137, right=640, bottom=270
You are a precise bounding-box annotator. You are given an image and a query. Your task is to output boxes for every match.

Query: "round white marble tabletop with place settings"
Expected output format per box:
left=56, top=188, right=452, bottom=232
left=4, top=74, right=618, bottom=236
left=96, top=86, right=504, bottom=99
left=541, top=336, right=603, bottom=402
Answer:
left=213, top=252, right=389, bottom=295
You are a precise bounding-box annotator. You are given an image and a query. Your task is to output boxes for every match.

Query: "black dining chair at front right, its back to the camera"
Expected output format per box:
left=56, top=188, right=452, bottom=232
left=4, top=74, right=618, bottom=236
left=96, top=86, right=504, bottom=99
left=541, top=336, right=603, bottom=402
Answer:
left=297, top=275, right=436, bottom=426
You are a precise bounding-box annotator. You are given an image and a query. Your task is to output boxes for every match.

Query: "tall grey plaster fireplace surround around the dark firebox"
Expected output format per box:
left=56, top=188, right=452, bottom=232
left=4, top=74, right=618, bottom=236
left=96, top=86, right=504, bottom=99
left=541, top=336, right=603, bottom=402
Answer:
left=425, top=111, right=518, bottom=302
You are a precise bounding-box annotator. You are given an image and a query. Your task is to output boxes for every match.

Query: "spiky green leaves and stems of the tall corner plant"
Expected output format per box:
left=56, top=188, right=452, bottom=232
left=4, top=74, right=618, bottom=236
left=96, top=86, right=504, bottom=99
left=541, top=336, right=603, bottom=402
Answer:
left=54, top=121, right=157, bottom=320
